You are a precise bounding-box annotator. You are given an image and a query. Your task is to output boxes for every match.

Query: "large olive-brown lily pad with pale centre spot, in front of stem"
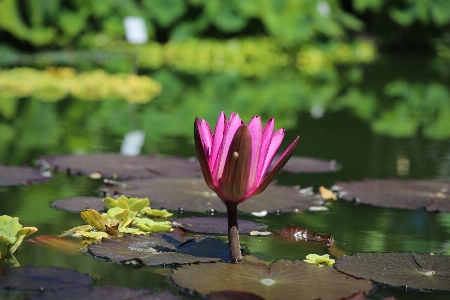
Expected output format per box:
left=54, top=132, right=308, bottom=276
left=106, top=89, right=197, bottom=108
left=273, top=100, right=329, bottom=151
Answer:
left=170, top=259, right=372, bottom=299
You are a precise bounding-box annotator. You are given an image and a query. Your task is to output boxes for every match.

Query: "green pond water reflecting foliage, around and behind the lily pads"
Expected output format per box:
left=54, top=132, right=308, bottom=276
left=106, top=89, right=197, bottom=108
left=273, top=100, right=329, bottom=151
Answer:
left=0, top=54, right=450, bottom=299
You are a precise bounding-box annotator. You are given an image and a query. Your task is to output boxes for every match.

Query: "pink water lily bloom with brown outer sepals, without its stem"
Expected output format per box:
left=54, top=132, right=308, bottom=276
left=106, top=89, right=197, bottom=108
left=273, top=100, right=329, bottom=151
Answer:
left=194, top=112, right=298, bottom=204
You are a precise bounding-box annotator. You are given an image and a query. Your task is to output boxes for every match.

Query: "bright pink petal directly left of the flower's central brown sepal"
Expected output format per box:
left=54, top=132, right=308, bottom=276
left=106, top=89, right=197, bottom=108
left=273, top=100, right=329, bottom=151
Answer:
left=213, top=113, right=242, bottom=183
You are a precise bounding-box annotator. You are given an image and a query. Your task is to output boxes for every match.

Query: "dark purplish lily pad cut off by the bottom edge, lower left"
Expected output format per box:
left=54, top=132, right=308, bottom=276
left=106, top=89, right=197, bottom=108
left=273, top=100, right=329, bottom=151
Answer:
left=27, top=287, right=181, bottom=300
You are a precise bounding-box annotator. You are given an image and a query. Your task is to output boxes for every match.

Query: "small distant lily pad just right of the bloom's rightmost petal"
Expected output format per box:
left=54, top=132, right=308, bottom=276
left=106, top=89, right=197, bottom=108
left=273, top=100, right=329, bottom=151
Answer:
left=272, top=155, right=341, bottom=173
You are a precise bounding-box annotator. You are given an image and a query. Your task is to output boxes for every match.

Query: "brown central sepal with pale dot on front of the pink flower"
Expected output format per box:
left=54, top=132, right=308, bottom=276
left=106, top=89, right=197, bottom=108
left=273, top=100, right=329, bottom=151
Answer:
left=219, top=125, right=252, bottom=202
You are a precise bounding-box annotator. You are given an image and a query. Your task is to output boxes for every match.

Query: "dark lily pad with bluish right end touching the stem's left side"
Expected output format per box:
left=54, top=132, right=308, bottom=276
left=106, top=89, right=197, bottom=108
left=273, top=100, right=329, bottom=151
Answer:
left=88, top=233, right=239, bottom=265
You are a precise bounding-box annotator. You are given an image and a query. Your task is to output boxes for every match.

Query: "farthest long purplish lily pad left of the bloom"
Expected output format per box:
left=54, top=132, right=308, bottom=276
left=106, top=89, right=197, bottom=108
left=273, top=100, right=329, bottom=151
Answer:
left=37, top=153, right=201, bottom=178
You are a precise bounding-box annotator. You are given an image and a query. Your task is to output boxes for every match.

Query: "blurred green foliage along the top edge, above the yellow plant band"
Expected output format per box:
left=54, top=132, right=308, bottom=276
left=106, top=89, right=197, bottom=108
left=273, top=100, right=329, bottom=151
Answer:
left=0, top=0, right=450, bottom=49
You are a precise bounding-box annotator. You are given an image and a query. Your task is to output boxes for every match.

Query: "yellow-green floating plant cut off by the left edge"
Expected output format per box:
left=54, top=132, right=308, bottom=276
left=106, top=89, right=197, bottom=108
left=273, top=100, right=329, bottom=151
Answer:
left=0, top=215, right=37, bottom=260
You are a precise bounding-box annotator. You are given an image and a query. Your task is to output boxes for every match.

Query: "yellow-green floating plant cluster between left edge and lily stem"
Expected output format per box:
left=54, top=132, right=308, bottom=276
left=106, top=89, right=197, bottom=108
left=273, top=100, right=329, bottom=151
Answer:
left=62, top=196, right=173, bottom=243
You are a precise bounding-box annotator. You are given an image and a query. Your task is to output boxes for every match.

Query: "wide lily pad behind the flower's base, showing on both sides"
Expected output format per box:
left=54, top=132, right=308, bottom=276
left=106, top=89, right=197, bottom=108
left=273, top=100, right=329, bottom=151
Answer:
left=102, top=178, right=320, bottom=212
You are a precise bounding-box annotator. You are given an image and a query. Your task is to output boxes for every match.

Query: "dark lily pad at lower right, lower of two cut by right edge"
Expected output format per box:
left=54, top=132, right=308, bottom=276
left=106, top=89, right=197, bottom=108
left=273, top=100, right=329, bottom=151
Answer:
left=334, top=252, right=450, bottom=291
